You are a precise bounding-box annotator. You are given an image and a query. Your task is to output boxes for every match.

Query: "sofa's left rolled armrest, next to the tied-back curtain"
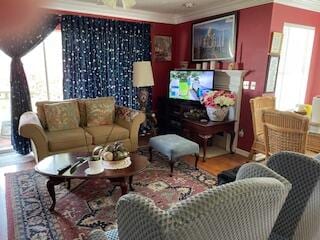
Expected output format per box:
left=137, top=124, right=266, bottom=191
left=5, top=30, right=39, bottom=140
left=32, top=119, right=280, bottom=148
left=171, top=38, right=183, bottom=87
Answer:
left=19, top=112, right=49, bottom=160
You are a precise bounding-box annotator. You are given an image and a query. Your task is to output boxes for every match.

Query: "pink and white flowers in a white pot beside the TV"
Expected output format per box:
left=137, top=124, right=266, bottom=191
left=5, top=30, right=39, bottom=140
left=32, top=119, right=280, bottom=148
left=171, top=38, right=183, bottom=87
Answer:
left=201, top=90, right=236, bottom=122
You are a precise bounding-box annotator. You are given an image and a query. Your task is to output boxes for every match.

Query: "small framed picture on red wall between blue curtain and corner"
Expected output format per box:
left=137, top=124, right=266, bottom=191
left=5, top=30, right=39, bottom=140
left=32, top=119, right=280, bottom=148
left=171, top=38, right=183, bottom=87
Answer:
left=154, top=36, right=172, bottom=61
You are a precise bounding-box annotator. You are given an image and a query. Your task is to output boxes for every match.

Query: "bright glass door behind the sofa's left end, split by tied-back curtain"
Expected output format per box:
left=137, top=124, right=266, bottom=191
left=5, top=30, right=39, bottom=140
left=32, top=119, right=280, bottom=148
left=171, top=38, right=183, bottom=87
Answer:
left=0, top=31, right=63, bottom=152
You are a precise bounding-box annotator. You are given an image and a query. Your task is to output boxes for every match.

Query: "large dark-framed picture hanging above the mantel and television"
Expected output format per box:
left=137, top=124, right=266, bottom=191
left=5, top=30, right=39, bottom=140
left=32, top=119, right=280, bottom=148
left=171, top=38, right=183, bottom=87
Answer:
left=192, top=13, right=237, bottom=61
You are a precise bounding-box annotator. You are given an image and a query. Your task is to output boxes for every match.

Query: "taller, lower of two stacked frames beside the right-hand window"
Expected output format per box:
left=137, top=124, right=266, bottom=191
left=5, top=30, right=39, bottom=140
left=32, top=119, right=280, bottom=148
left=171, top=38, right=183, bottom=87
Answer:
left=264, top=56, right=280, bottom=93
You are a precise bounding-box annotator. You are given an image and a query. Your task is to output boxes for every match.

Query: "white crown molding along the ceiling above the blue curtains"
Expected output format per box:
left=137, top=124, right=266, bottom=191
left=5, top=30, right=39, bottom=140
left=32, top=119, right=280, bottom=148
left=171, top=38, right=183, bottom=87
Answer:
left=43, top=0, right=176, bottom=24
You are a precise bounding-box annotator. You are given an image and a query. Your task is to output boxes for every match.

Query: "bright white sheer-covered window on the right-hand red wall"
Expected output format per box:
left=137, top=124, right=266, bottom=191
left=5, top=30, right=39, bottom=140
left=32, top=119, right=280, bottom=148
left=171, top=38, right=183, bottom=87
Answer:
left=275, top=23, right=315, bottom=110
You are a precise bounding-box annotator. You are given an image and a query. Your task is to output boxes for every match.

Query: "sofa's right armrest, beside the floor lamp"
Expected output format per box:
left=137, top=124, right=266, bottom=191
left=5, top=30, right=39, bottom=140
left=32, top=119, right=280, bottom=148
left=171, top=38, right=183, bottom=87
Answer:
left=115, top=106, right=146, bottom=152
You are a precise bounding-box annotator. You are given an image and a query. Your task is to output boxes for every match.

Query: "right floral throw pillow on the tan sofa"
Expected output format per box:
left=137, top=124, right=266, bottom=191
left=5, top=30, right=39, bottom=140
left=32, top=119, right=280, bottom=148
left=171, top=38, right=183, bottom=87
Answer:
left=86, top=100, right=115, bottom=127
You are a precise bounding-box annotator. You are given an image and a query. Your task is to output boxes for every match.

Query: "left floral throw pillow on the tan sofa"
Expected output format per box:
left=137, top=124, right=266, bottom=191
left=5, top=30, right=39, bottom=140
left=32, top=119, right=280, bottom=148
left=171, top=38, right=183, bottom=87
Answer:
left=43, top=102, right=80, bottom=131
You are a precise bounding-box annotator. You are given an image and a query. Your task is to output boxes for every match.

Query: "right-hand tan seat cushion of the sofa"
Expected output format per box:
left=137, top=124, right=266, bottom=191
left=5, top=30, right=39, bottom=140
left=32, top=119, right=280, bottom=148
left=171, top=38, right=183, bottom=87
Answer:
left=85, top=124, right=129, bottom=145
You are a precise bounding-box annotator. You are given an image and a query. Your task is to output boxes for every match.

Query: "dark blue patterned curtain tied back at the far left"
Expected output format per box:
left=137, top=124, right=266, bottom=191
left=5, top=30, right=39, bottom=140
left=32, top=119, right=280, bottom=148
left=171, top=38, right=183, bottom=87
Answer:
left=0, top=15, right=59, bottom=154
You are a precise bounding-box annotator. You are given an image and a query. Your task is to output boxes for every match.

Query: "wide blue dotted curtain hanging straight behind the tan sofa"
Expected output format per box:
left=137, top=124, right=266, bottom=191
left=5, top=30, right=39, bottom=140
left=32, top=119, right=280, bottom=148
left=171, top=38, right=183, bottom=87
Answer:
left=61, top=16, right=151, bottom=109
